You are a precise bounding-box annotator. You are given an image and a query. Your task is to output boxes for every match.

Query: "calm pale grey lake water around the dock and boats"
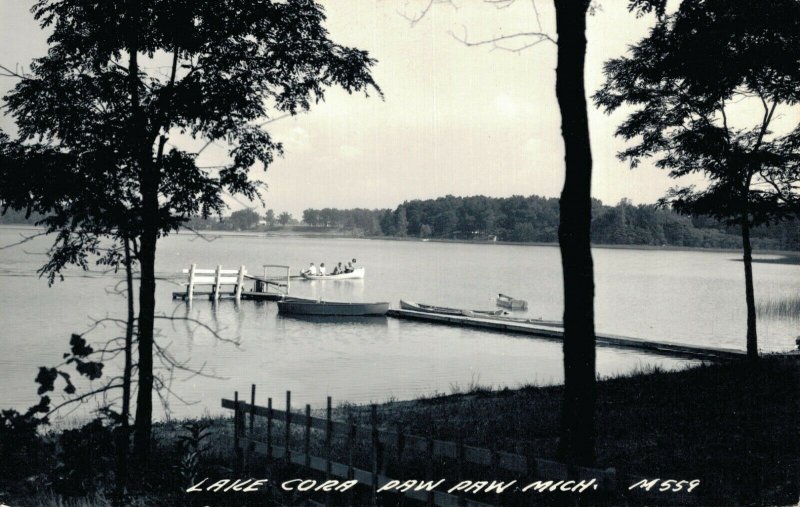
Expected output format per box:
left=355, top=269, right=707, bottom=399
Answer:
left=0, top=227, right=800, bottom=417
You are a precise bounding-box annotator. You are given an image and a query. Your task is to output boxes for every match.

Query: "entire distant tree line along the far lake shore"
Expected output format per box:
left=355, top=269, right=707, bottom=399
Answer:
left=0, top=195, right=800, bottom=251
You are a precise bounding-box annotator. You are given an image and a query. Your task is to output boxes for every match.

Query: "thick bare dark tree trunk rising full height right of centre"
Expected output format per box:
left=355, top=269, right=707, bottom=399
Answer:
left=555, top=0, right=596, bottom=465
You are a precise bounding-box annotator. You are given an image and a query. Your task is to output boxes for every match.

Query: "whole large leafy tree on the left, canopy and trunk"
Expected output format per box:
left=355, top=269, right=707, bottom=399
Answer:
left=6, top=0, right=380, bottom=461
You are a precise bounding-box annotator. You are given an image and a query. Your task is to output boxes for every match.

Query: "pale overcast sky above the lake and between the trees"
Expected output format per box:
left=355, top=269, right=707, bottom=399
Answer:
left=0, top=0, right=720, bottom=216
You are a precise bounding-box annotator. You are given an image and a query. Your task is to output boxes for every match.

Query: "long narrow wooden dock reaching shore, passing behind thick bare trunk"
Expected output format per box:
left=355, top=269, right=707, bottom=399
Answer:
left=386, top=309, right=747, bottom=361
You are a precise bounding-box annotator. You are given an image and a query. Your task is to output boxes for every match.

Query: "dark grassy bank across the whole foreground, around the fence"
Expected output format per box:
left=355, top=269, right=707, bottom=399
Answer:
left=0, top=356, right=800, bottom=507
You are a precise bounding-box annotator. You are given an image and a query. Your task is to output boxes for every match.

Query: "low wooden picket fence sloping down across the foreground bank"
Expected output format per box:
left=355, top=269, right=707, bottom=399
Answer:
left=222, top=385, right=616, bottom=506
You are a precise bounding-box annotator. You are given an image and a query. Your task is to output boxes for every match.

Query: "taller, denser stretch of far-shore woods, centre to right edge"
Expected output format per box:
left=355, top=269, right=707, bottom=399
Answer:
left=370, top=195, right=800, bottom=251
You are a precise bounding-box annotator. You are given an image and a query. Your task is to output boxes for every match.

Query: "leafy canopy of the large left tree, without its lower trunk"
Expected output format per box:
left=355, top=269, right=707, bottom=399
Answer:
left=0, top=0, right=380, bottom=260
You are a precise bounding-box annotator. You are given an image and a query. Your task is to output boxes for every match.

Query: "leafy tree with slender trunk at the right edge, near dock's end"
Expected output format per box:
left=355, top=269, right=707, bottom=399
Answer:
left=594, top=0, right=800, bottom=358
